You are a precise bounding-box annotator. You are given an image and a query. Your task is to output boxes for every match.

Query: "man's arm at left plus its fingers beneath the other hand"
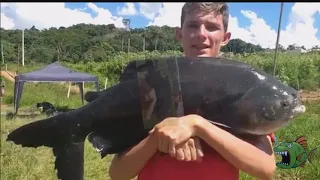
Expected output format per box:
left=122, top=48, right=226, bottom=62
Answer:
left=109, top=131, right=203, bottom=180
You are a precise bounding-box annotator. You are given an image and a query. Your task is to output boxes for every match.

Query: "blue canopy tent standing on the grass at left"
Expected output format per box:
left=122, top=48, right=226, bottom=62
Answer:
left=14, top=62, right=99, bottom=114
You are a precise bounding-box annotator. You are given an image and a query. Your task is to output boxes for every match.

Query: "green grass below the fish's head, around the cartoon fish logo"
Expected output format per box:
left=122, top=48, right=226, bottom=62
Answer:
left=241, top=101, right=320, bottom=180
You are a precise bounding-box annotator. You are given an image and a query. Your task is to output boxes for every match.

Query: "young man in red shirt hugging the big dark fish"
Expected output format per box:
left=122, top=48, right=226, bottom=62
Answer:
left=109, top=2, right=275, bottom=180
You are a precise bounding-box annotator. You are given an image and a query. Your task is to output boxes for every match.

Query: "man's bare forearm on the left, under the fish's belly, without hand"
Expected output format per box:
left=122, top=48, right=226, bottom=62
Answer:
left=109, top=136, right=158, bottom=180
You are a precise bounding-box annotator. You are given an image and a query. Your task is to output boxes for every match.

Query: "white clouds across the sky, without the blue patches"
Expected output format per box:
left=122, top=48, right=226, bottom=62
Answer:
left=1, top=3, right=320, bottom=48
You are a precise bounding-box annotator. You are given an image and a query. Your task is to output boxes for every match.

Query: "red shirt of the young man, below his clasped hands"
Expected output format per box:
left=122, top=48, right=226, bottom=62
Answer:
left=138, top=134, right=274, bottom=180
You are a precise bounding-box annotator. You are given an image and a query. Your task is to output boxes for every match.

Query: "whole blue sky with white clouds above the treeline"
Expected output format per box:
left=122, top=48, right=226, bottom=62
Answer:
left=1, top=2, right=320, bottom=48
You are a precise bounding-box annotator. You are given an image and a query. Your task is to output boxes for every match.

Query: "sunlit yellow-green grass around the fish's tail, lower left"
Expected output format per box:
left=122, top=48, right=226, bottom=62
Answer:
left=1, top=117, right=111, bottom=180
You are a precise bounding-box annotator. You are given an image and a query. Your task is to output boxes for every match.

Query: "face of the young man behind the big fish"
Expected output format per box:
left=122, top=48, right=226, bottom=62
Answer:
left=176, top=10, right=231, bottom=57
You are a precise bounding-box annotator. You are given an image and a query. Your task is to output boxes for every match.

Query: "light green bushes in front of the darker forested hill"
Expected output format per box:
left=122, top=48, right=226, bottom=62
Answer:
left=3, top=51, right=320, bottom=90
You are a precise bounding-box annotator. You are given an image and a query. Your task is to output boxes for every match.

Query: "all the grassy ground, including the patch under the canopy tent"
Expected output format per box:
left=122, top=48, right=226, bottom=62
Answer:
left=0, top=59, right=320, bottom=180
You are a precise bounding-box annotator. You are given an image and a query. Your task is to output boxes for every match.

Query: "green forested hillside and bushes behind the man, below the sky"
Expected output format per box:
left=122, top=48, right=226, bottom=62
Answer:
left=0, top=24, right=320, bottom=89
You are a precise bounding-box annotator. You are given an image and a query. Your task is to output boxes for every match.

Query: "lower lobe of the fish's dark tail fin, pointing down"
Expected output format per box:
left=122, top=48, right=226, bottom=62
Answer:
left=52, top=141, right=84, bottom=180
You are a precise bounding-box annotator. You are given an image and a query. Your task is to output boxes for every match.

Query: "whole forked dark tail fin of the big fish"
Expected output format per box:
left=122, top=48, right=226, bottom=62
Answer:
left=7, top=114, right=86, bottom=180
